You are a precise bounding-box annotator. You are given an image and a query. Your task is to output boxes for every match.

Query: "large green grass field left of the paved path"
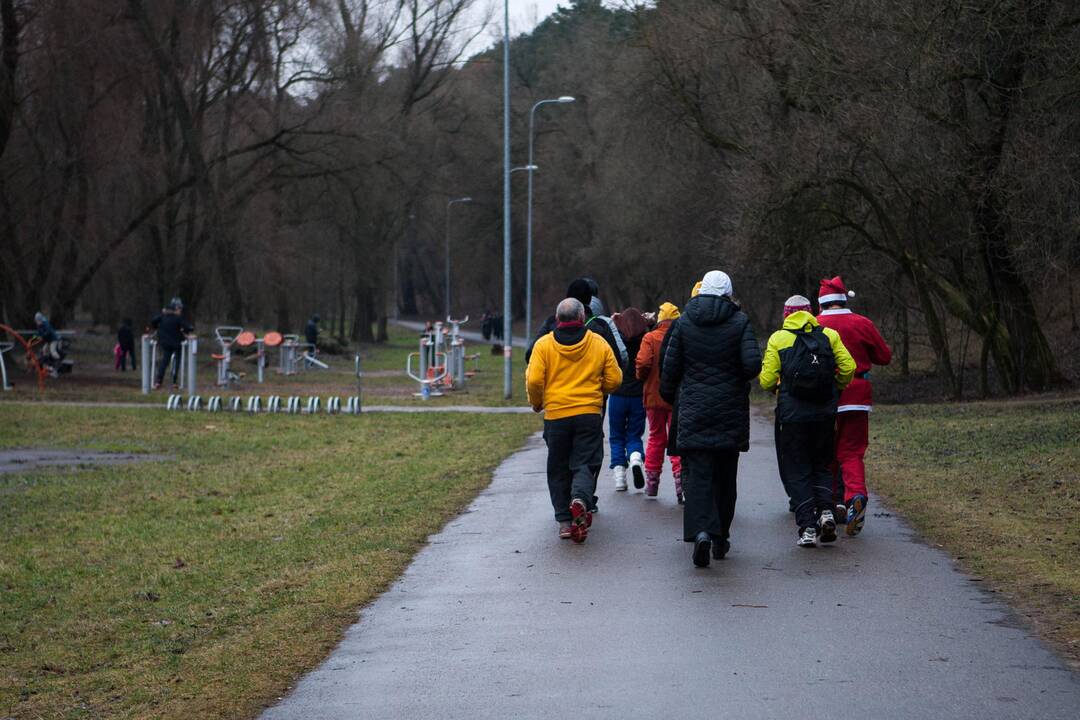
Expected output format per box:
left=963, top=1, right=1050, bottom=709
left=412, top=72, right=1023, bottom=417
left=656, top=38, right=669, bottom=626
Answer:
left=0, top=406, right=540, bottom=719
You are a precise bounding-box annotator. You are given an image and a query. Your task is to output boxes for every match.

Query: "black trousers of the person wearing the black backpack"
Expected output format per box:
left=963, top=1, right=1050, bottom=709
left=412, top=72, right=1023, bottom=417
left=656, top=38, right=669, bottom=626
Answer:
left=777, top=418, right=834, bottom=528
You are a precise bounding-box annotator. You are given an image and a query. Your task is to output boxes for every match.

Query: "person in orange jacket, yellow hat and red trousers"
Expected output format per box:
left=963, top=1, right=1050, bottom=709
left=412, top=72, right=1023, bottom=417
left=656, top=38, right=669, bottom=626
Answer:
left=634, top=302, right=683, bottom=505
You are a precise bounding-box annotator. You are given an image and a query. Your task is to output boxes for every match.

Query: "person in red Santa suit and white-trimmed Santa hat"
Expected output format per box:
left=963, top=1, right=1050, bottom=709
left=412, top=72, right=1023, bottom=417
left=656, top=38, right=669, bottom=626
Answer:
left=818, top=275, right=892, bottom=536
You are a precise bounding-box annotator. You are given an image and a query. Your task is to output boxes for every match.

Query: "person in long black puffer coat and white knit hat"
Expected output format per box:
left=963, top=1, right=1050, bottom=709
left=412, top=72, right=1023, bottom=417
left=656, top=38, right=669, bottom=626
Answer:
left=660, top=270, right=761, bottom=568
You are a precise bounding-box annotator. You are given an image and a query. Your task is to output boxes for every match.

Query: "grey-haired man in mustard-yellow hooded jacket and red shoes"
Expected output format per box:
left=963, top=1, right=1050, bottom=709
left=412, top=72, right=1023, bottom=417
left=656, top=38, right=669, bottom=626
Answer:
left=525, top=298, right=622, bottom=543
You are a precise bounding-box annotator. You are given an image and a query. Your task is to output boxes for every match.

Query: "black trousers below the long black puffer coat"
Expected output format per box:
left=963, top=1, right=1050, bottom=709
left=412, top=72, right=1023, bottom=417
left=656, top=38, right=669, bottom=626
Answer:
left=681, top=449, right=739, bottom=543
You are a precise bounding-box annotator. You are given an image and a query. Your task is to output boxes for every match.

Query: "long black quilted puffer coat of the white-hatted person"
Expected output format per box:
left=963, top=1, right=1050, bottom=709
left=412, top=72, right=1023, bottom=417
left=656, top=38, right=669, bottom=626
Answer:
left=660, top=295, right=761, bottom=451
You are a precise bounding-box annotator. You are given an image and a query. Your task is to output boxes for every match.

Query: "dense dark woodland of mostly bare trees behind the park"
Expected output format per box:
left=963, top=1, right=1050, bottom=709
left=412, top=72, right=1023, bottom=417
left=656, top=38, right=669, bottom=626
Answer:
left=0, top=0, right=1080, bottom=396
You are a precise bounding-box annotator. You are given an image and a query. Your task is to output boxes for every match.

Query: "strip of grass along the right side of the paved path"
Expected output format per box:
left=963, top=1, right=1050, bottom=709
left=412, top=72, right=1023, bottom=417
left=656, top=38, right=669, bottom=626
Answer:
left=867, top=398, right=1080, bottom=667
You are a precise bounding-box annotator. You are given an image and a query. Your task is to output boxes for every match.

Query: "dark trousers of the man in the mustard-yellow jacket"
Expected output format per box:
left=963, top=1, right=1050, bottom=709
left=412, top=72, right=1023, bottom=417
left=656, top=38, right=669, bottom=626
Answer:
left=543, top=413, right=604, bottom=521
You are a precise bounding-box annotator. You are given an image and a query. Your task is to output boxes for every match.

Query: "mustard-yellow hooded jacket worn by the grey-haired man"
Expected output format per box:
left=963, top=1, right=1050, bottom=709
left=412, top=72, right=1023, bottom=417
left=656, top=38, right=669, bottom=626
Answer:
left=525, top=330, right=622, bottom=420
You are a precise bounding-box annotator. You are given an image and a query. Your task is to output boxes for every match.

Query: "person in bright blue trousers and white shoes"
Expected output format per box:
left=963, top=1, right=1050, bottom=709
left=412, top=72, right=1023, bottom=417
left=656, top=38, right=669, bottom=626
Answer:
left=609, top=306, right=649, bottom=491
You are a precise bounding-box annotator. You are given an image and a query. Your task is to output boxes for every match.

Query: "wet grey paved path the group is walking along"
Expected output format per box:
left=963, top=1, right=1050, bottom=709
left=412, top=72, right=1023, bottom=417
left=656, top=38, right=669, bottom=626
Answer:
left=262, top=410, right=1080, bottom=720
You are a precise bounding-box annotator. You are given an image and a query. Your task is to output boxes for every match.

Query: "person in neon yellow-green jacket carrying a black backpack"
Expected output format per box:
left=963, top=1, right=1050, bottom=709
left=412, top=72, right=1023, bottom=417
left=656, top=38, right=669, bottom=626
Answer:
left=758, top=295, right=855, bottom=547
